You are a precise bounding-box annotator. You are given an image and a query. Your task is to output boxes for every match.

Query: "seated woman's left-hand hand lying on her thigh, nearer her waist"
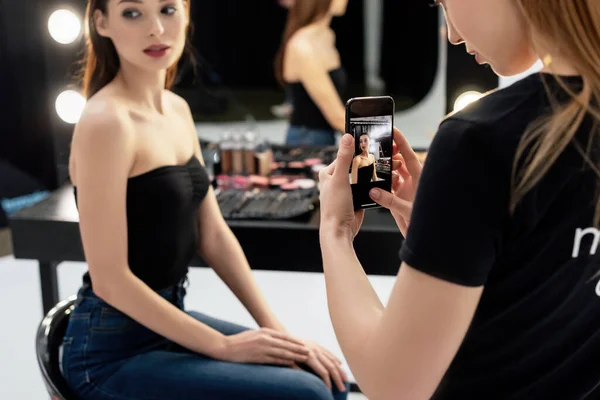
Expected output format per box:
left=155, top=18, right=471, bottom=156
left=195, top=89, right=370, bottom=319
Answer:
left=217, top=328, right=309, bottom=366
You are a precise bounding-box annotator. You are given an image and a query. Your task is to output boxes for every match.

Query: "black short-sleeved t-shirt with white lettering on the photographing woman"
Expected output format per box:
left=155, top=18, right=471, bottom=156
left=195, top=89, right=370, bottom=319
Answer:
left=400, top=74, right=600, bottom=400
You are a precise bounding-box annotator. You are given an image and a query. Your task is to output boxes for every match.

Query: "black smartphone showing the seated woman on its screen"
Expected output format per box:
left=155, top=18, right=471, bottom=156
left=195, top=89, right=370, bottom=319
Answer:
left=346, top=96, right=395, bottom=210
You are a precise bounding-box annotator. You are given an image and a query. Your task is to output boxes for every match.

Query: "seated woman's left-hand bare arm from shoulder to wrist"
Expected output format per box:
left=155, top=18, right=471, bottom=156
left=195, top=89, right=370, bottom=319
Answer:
left=72, top=102, right=226, bottom=357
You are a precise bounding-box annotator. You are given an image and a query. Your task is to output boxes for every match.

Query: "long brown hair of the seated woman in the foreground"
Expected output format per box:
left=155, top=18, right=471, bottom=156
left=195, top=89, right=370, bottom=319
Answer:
left=81, top=0, right=194, bottom=99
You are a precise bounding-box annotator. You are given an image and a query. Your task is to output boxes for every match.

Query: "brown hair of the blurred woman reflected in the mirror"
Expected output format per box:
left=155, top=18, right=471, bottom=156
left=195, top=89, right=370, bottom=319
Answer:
left=275, top=0, right=332, bottom=86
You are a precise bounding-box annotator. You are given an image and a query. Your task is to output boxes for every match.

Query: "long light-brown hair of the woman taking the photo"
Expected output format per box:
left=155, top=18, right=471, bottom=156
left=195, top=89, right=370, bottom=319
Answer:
left=511, top=0, right=600, bottom=225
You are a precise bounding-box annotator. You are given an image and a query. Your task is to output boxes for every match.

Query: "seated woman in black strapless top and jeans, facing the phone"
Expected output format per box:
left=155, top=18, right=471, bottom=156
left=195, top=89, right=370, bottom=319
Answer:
left=62, top=0, right=347, bottom=400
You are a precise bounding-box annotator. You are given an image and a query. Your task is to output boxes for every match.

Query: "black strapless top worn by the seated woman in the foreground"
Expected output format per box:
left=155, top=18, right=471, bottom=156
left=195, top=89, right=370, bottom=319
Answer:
left=74, top=156, right=210, bottom=290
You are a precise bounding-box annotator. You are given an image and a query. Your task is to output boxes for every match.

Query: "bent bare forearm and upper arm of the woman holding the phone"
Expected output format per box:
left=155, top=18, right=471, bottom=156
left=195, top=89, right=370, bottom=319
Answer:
left=320, top=230, right=483, bottom=400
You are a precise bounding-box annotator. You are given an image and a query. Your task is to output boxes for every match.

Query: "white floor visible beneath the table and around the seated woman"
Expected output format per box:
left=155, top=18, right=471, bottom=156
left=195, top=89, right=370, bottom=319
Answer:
left=0, top=257, right=393, bottom=400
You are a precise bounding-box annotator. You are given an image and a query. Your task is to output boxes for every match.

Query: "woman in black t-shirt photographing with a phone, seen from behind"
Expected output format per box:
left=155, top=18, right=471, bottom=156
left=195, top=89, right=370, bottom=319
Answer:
left=320, top=0, right=600, bottom=400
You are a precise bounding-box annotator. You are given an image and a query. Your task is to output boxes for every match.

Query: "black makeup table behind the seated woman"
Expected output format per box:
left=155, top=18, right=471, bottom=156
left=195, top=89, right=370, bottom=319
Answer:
left=10, top=184, right=403, bottom=315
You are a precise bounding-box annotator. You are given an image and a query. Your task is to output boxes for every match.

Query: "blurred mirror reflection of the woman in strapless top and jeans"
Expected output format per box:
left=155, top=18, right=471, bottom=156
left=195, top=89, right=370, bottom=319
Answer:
left=275, top=0, right=348, bottom=146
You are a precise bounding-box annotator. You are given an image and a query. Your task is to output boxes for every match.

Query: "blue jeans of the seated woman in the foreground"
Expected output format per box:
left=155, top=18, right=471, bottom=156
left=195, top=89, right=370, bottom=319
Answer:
left=62, top=284, right=347, bottom=400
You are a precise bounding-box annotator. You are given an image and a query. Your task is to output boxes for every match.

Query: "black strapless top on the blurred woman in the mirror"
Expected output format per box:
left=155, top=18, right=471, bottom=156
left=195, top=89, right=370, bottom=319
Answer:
left=288, top=67, right=348, bottom=131
